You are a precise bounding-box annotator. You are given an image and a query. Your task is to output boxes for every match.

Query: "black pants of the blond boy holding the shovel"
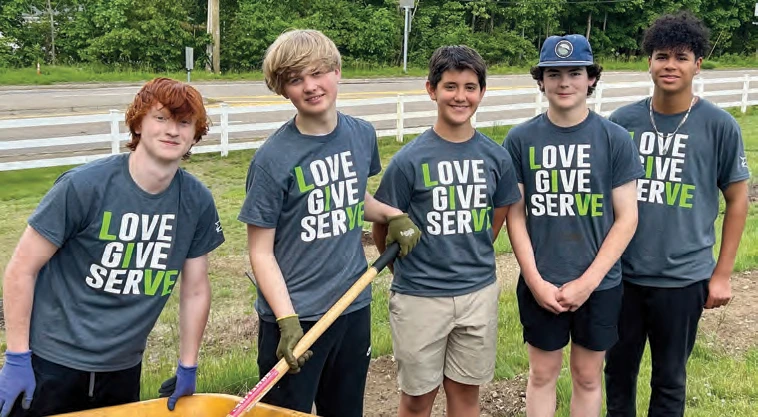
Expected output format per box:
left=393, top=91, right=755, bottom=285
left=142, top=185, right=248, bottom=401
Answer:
left=258, top=307, right=371, bottom=417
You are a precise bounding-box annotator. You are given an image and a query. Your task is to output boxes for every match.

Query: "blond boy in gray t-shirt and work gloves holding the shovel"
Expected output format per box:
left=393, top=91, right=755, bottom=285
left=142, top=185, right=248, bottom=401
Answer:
left=239, top=30, right=420, bottom=417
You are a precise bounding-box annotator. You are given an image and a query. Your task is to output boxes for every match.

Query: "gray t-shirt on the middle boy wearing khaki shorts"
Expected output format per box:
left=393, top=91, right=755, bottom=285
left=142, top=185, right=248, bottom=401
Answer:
left=375, top=129, right=521, bottom=297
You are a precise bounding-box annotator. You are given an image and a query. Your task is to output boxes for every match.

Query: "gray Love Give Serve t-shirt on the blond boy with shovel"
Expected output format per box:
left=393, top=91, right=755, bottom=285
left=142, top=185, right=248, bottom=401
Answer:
left=238, top=113, right=382, bottom=321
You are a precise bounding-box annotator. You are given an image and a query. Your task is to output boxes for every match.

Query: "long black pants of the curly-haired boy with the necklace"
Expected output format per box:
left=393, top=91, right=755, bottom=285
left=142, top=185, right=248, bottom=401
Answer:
left=605, top=280, right=708, bottom=417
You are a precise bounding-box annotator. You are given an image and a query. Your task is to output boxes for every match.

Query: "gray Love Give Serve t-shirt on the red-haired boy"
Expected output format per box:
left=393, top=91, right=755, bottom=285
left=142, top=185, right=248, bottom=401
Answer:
left=29, top=154, right=229, bottom=372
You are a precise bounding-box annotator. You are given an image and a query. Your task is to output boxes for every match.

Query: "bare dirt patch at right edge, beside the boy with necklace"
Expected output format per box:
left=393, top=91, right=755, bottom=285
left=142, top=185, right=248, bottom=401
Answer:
left=700, top=271, right=758, bottom=356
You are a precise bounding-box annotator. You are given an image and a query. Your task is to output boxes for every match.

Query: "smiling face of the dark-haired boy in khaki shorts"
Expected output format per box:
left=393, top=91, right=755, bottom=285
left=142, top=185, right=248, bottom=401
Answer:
left=427, top=69, right=485, bottom=126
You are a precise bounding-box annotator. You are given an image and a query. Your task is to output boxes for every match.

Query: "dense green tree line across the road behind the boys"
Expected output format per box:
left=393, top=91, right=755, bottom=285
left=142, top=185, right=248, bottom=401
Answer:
left=0, top=0, right=758, bottom=71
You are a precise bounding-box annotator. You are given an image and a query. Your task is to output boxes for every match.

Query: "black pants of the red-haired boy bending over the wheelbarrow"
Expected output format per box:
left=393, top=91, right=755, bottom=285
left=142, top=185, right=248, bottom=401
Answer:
left=10, top=355, right=142, bottom=417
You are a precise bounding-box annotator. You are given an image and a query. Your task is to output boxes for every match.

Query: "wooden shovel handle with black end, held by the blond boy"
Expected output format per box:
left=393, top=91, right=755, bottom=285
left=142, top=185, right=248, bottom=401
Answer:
left=226, top=243, right=400, bottom=417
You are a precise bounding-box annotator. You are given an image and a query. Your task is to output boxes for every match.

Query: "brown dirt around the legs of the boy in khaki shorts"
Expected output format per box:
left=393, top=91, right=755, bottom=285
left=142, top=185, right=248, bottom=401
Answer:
left=364, top=356, right=526, bottom=417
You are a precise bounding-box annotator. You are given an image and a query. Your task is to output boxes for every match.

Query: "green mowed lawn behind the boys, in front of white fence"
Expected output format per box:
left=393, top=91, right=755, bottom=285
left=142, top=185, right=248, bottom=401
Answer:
left=0, top=110, right=758, bottom=417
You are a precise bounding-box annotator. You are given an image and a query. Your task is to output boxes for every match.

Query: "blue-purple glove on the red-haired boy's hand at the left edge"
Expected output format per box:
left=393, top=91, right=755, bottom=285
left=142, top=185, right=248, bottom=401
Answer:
left=0, top=350, right=37, bottom=417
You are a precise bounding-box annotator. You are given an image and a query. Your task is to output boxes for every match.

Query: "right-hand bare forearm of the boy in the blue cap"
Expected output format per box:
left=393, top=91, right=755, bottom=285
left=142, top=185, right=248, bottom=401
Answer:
left=582, top=210, right=637, bottom=287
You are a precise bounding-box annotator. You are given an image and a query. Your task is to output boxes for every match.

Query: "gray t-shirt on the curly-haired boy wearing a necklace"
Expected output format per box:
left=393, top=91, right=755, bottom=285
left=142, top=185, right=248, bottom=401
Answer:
left=611, top=98, right=750, bottom=288
